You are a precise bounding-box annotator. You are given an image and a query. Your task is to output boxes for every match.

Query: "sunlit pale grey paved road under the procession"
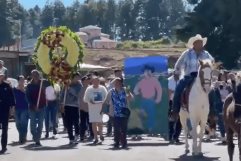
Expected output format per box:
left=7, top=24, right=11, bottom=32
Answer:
left=0, top=123, right=238, bottom=161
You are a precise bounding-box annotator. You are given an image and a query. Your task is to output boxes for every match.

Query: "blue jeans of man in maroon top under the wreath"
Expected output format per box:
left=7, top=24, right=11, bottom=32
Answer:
left=29, top=108, right=44, bottom=143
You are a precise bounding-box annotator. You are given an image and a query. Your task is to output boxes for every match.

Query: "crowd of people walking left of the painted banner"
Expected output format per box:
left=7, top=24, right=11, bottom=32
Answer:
left=0, top=62, right=133, bottom=153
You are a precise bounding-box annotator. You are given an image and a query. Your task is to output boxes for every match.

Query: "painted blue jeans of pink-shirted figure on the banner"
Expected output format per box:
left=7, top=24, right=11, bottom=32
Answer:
left=141, top=98, right=156, bottom=132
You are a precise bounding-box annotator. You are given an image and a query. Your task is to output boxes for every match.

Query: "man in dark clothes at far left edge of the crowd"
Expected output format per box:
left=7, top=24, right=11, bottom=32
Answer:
left=0, top=71, right=15, bottom=154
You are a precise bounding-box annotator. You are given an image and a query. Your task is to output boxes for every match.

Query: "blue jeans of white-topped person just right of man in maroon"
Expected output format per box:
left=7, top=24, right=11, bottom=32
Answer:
left=45, top=101, right=57, bottom=134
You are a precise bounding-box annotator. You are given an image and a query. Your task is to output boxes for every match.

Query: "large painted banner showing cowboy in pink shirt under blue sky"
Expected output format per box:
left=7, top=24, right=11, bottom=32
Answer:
left=124, top=56, right=168, bottom=137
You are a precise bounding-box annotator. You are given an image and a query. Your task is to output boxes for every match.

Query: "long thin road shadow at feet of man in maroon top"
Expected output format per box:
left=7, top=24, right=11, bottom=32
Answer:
left=21, top=144, right=78, bottom=151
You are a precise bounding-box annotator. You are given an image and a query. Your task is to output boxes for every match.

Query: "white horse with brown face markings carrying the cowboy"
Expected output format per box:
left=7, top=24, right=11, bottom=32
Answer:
left=179, top=60, right=213, bottom=156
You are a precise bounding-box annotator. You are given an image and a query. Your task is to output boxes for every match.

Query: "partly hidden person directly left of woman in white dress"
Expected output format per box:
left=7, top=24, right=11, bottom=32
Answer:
left=80, top=75, right=94, bottom=141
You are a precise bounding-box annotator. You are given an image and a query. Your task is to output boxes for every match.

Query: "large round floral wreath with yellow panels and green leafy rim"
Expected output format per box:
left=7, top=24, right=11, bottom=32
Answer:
left=33, top=26, right=84, bottom=84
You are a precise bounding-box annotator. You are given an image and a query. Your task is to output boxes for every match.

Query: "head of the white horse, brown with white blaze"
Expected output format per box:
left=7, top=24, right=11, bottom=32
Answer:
left=198, top=59, right=213, bottom=93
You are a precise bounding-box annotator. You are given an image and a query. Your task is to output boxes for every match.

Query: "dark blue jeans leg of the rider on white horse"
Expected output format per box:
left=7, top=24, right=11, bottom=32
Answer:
left=173, top=76, right=195, bottom=113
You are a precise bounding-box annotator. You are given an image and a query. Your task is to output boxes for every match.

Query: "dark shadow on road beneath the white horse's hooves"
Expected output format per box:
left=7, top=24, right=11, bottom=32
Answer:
left=170, top=154, right=220, bottom=161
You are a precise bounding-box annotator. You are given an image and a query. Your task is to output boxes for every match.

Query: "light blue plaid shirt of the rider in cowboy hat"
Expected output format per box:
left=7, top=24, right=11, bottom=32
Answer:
left=175, top=49, right=214, bottom=75
